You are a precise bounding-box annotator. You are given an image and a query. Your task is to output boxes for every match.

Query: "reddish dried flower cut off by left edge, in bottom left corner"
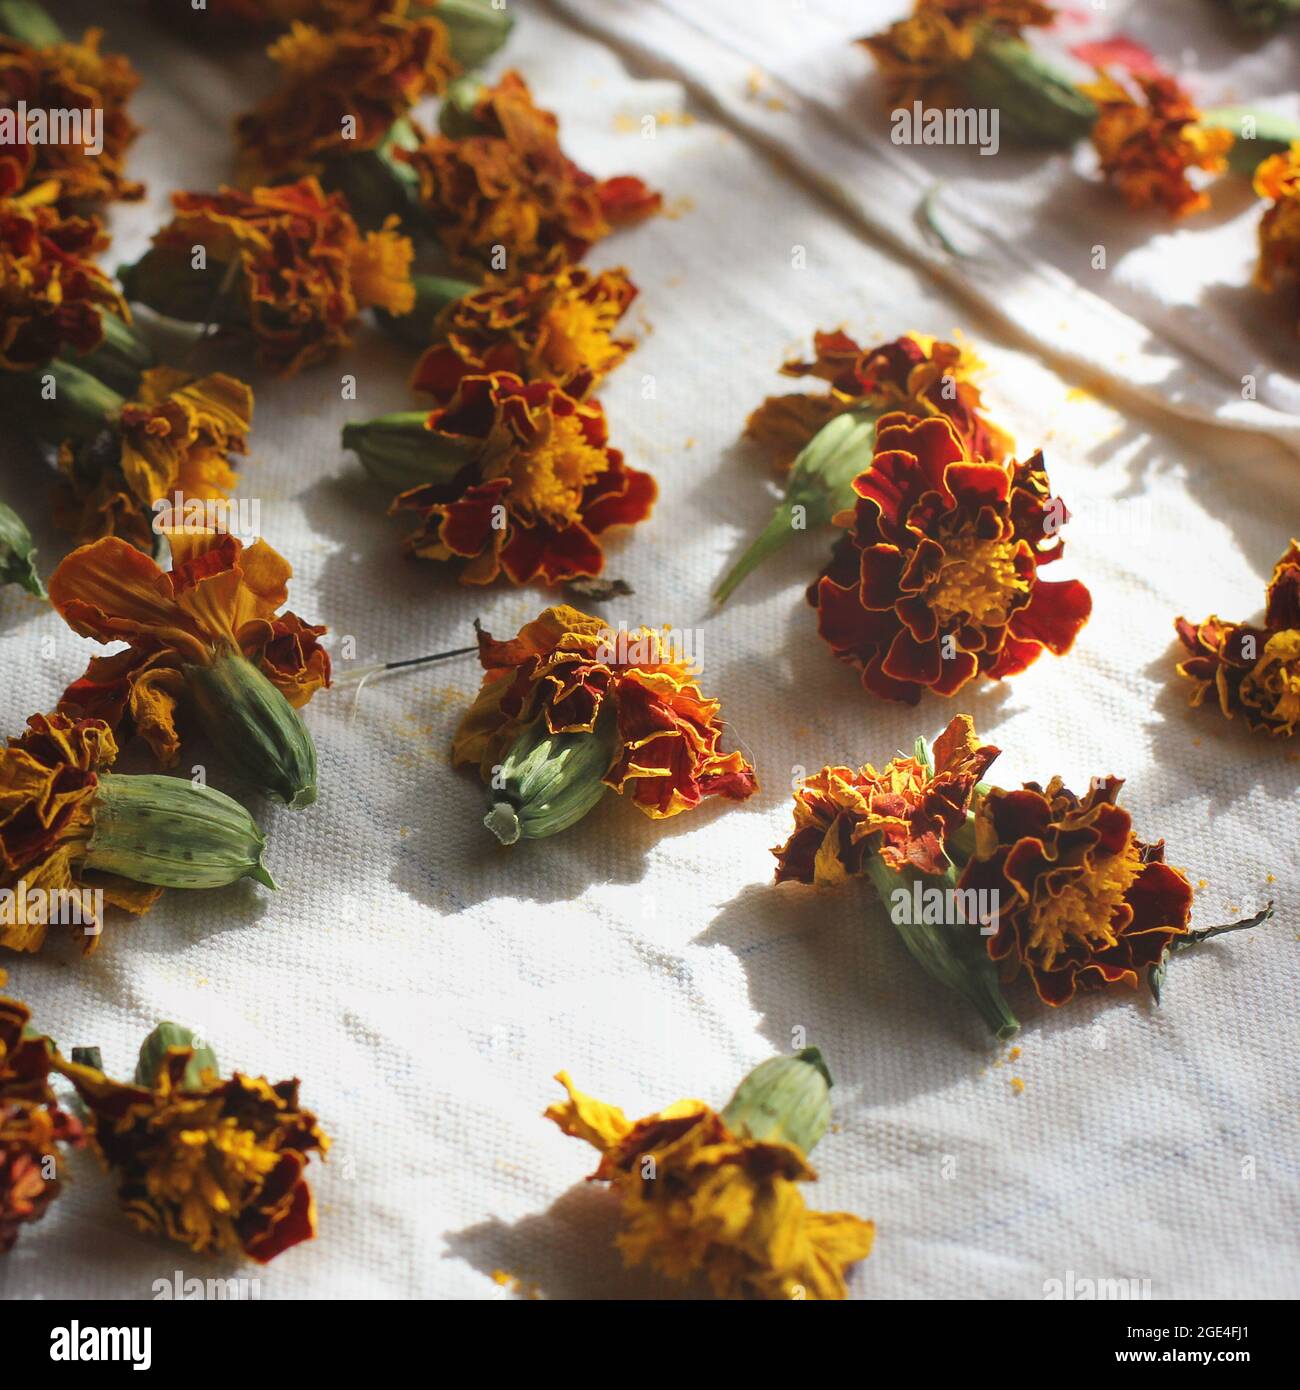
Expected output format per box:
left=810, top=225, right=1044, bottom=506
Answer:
left=0, top=970, right=83, bottom=1255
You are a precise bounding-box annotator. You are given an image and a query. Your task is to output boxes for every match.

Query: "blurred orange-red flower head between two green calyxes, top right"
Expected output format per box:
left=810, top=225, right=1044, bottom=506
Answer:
left=1083, top=68, right=1232, bottom=217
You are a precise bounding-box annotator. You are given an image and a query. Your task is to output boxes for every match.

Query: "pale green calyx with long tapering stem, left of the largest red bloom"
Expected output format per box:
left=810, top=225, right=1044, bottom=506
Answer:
left=713, top=409, right=877, bottom=606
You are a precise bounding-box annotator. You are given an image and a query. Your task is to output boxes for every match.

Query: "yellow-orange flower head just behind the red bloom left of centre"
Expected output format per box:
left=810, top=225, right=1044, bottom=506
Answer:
left=412, top=265, right=637, bottom=404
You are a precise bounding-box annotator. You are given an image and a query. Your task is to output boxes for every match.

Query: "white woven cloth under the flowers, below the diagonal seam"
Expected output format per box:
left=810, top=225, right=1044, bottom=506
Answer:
left=0, top=3, right=1300, bottom=1298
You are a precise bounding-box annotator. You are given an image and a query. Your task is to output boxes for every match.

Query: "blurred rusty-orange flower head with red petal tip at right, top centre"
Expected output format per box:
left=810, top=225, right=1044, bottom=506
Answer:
left=396, top=72, right=662, bottom=275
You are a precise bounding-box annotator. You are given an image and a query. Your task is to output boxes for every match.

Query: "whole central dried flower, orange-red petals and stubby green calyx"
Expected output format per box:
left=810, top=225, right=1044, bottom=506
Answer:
left=452, top=606, right=758, bottom=842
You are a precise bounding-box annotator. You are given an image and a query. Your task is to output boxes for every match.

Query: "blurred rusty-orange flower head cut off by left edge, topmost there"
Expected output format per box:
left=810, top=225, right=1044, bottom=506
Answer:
left=0, top=29, right=145, bottom=203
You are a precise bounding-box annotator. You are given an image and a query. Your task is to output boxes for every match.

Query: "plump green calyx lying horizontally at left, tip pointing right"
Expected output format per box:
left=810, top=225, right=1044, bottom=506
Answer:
left=82, top=773, right=275, bottom=888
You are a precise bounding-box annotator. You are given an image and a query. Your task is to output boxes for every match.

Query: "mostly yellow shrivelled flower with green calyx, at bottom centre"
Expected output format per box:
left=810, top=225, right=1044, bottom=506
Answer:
left=546, top=1048, right=875, bottom=1300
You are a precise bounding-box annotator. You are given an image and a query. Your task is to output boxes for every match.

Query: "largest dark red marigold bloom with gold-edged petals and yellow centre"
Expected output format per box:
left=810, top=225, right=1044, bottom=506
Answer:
left=808, top=414, right=1091, bottom=705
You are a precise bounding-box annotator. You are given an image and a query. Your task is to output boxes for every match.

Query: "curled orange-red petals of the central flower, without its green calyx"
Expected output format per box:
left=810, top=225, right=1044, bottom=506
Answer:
left=452, top=605, right=758, bottom=820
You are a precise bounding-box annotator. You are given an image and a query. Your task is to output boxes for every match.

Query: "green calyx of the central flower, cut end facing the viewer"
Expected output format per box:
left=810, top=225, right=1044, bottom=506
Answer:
left=482, top=703, right=617, bottom=845
